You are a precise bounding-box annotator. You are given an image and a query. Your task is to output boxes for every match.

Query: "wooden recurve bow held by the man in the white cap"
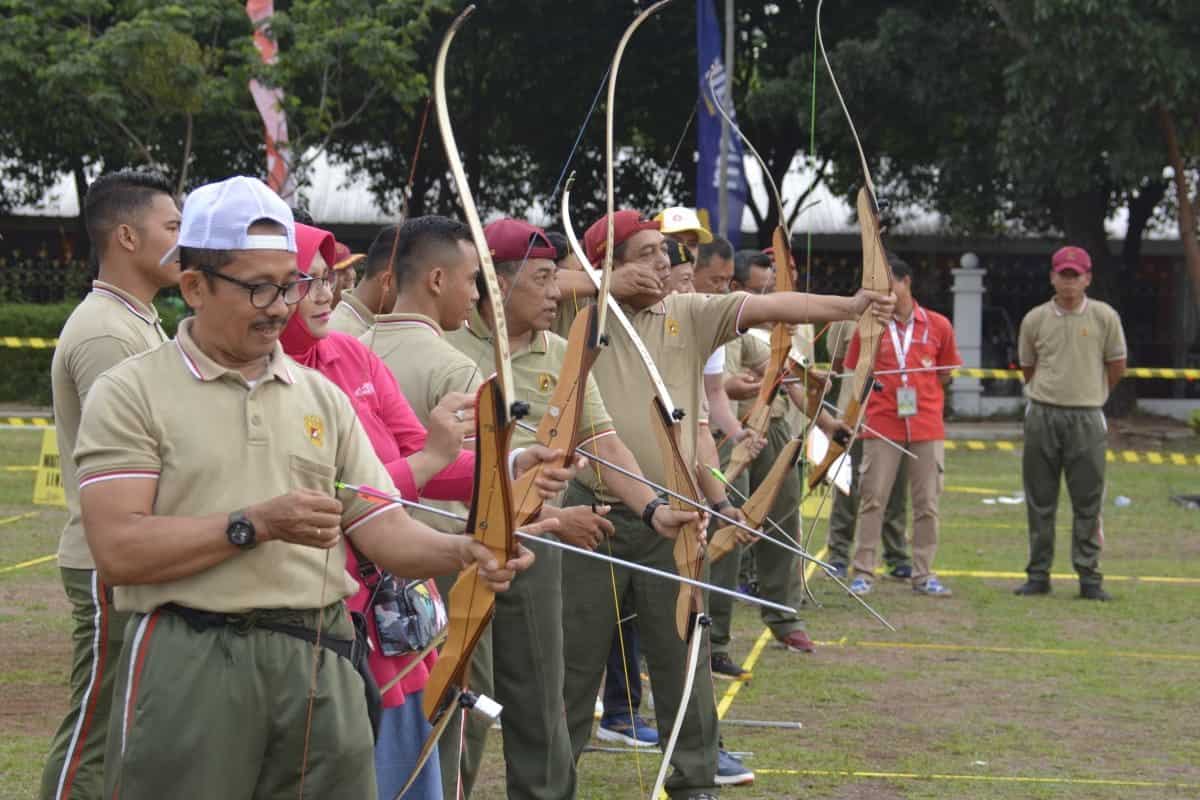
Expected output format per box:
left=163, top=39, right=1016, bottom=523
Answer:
left=414, top=6, right=526, bottom=758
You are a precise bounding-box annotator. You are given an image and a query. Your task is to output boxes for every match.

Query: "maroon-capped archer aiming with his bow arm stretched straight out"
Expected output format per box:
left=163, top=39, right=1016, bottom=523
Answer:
left=563, top=211, right=895, bottom=796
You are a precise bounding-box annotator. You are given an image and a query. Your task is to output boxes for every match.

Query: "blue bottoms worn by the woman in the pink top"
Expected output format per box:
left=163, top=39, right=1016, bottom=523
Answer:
left=376, top=692, right=442, bottom=800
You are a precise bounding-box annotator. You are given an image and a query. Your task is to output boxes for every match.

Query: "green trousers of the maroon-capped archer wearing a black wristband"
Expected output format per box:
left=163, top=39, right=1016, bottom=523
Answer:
left=492, top=545, right=575, bottom=800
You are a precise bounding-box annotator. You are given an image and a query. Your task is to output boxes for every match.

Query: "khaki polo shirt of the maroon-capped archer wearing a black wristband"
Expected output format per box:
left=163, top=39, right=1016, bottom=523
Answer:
left=446, top=309, right=613, bottom=447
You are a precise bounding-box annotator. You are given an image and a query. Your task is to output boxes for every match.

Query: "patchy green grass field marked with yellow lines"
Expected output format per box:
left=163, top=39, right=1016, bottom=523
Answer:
left=0, top=431, right=1200, bottom=800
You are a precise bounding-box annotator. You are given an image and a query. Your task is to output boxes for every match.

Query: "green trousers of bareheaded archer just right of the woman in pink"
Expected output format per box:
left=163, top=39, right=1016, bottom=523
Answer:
left=434, top=573, right=492, bottom=798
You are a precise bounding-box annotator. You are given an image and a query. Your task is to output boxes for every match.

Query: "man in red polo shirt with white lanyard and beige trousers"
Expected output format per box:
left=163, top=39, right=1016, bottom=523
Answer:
left=846, top=253, right=962, bottom=597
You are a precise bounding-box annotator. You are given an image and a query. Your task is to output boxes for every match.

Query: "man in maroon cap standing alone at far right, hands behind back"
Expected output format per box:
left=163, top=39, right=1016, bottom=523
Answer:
left=1016, top=247, right=1127, bottom=601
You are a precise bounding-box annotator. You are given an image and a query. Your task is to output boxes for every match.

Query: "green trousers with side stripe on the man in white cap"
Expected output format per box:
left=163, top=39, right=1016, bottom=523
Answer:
left=104, top=602, right=376, bottom=800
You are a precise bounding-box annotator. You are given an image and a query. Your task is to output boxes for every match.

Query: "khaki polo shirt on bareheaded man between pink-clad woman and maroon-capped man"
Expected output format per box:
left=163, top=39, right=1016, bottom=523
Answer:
left=359, top=313, right=480, bottom=533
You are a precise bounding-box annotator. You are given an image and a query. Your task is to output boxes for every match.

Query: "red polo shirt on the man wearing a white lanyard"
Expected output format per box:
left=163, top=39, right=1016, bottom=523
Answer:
left=846, top=302, right=962, bottom=441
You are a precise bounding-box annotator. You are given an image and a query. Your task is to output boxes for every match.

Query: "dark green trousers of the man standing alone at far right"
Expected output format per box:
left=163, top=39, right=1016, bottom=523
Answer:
left=1021, top=402, right=1108, bottom=585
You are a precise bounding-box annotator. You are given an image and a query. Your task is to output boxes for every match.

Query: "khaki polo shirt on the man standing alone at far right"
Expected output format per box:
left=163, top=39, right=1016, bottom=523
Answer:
left=1018, top=297, right=1127, bottom=408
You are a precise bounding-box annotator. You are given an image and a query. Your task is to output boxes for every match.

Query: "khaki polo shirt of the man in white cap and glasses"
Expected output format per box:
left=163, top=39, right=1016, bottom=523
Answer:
left=74, top=320, right=398, bottom=613
